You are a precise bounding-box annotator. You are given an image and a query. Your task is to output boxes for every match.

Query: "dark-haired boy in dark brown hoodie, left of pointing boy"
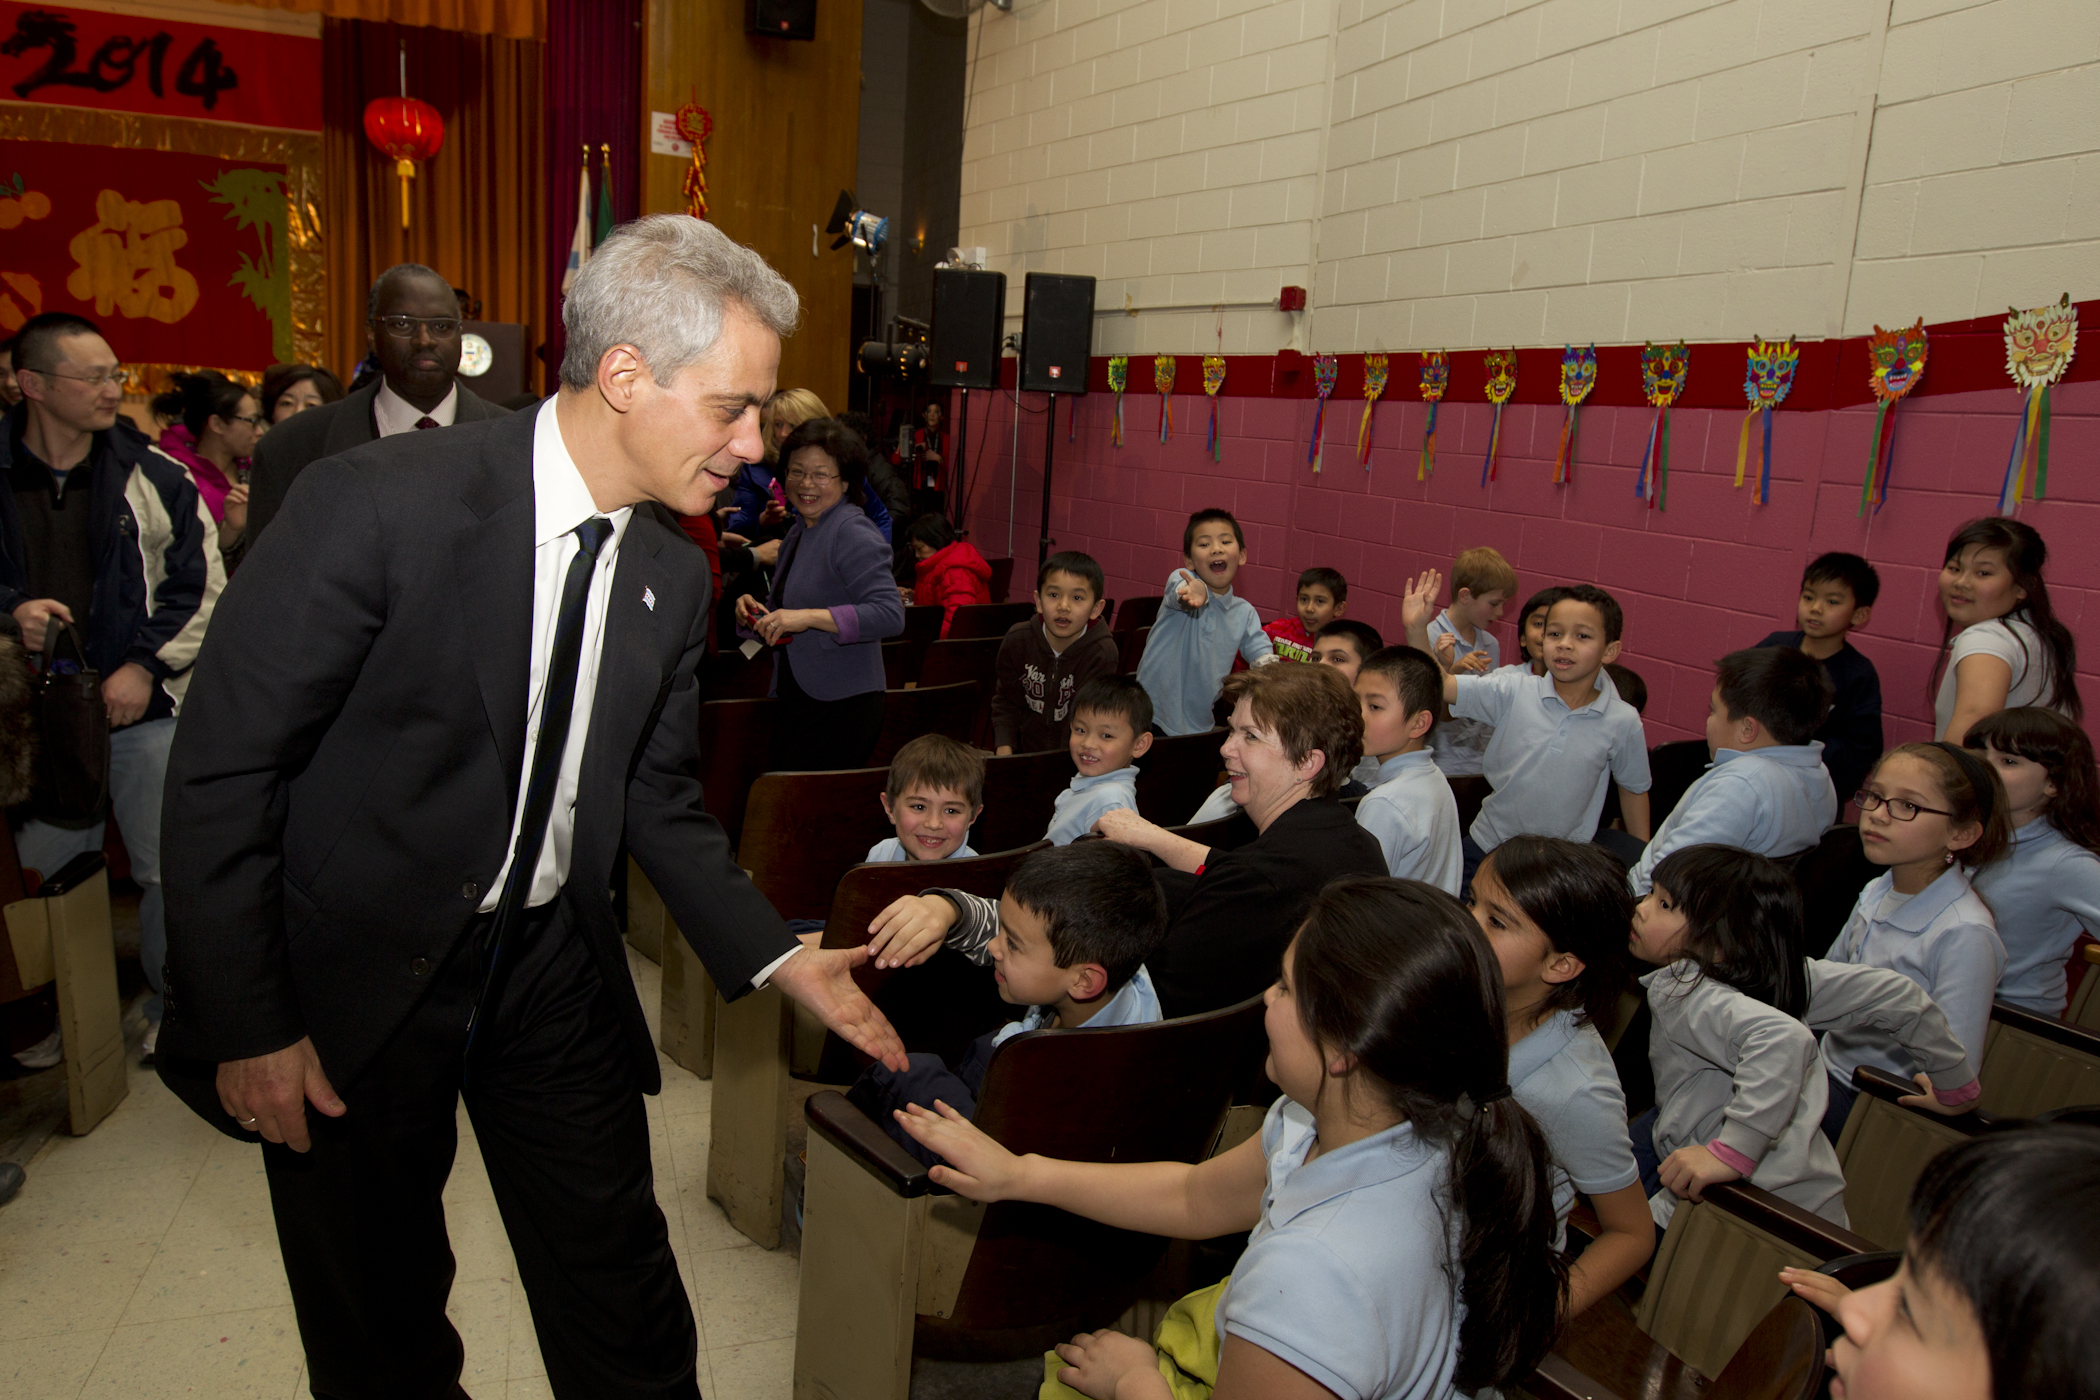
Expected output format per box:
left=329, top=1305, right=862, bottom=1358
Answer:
left=991, top=550, right=1121, bottom=756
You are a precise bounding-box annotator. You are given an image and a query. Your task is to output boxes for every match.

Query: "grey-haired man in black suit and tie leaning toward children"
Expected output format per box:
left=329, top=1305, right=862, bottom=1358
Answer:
left=160, top=214, right=905, bottom=1400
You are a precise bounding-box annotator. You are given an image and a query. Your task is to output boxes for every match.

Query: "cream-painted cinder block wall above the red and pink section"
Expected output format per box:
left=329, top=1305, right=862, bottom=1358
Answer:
left=962, top=0, right=2100, bottom=353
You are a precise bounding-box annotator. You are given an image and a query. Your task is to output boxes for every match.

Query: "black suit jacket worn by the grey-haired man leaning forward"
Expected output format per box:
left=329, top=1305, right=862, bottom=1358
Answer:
left=160, top=398, right=796, bottom=1119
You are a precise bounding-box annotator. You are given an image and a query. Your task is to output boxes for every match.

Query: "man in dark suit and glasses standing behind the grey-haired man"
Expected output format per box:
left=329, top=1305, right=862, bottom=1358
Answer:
left=248, top=262, right=508, bottom=548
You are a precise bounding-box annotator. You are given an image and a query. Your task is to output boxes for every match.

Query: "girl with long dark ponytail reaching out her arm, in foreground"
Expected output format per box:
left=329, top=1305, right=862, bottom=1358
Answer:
left=897, top=877, right=1567, bottom=1400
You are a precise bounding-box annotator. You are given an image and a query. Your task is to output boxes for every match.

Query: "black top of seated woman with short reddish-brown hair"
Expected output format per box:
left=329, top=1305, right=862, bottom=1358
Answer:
left=1142, top=797, right=1386, bottom=1016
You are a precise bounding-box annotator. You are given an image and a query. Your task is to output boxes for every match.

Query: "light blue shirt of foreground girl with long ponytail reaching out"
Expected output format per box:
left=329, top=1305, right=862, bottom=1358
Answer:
left=1218, top=1098, right=1460, bottom=1400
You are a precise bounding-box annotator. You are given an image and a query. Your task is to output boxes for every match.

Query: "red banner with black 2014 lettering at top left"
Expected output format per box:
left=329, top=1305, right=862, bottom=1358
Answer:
left=0, top=0, right=321, bottom=130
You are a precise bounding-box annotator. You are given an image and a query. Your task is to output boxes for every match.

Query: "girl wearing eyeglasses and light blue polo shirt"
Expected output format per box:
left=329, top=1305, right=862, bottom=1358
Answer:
left=1823, top=741, right=2012, bottom=1142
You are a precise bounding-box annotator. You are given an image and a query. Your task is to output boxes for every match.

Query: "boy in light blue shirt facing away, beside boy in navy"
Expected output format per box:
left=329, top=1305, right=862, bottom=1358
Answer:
left=1630, top=646, right=1838, bottom=894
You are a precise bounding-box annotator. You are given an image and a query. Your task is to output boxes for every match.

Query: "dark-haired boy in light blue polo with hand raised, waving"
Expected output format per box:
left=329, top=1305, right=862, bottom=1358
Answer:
left=1401, top=569, right=1649, bottom=884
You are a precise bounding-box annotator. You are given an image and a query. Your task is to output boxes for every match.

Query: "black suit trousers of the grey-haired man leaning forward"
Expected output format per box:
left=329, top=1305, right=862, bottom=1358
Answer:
left=263, top=900, right=699, bottom=1400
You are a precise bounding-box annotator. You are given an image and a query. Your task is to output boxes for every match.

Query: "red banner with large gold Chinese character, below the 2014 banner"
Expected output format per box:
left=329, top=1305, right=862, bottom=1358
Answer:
left=0, top=141, right=292, bottom=369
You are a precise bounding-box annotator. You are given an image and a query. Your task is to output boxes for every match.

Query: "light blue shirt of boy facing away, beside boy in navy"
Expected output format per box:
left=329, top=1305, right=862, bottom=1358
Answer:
left=1628, top=739, right=1838, bottom=894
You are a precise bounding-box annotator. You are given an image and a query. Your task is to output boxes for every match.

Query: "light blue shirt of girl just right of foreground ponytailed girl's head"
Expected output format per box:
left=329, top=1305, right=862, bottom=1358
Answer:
left=1510, top=1012, right=1640, bottom=1249
